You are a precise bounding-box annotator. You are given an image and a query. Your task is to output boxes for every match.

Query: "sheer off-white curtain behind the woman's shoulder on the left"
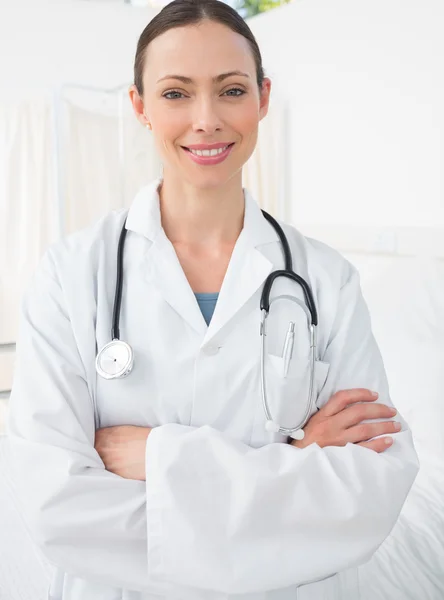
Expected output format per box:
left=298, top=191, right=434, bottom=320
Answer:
left=0, top=89, right=160, bottom=332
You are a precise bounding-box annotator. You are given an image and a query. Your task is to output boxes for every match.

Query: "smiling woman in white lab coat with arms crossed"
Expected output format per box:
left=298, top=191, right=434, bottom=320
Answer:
left=9, top=0, right=418, bottom=600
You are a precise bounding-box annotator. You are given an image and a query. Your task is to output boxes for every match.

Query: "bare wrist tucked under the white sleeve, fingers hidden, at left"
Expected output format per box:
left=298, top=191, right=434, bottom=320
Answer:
left=94, top=425, right=151, bottom=481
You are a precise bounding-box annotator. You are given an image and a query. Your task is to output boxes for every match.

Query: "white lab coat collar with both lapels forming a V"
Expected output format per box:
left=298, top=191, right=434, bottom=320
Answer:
left=126, top=179, right=279, bottom=345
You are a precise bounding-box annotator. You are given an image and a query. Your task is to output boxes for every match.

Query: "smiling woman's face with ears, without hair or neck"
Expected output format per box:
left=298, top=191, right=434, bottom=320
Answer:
left=130, top=21, right=271, bottom=188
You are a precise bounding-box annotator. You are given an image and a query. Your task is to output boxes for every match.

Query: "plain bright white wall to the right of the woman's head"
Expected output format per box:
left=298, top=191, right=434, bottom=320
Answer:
left=249, top=0, right=444, bottom=226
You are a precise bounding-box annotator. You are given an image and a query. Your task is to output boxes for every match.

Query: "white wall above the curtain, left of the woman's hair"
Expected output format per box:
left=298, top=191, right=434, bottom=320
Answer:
left=0, top=0, right=160, bottom=102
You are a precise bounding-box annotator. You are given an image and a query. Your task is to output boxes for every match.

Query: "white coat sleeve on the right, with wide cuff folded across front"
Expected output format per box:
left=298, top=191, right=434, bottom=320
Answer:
left=146, top=265, right=418, bottom=594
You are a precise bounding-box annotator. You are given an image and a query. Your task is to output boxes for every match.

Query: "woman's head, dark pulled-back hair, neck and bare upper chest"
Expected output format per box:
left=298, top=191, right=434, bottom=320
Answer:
left=124, top=0, right=271, bottom=293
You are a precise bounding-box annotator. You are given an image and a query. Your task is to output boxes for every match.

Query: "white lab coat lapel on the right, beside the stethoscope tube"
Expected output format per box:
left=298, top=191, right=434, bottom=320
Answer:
left=203, top=190, right=279, bottom=344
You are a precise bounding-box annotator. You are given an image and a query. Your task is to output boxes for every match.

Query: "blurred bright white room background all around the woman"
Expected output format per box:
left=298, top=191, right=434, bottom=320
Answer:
left=0, top=0, right=444, bottom=600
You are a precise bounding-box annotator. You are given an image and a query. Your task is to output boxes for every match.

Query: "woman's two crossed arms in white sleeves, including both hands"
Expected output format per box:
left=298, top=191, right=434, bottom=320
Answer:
left=8, top=250, right=418, bottom=594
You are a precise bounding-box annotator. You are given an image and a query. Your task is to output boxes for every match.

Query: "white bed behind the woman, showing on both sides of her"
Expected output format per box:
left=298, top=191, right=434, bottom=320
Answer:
left=0, top=227, right=444, bottom=600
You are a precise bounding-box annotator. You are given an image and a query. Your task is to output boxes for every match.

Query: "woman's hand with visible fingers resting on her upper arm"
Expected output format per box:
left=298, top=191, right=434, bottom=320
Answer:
left=291, top=389, right=400, bottom=453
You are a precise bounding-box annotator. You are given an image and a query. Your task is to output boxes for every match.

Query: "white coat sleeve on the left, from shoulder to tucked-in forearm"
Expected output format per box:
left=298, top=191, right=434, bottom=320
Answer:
left=4, top=252, right=165, bottom=591
